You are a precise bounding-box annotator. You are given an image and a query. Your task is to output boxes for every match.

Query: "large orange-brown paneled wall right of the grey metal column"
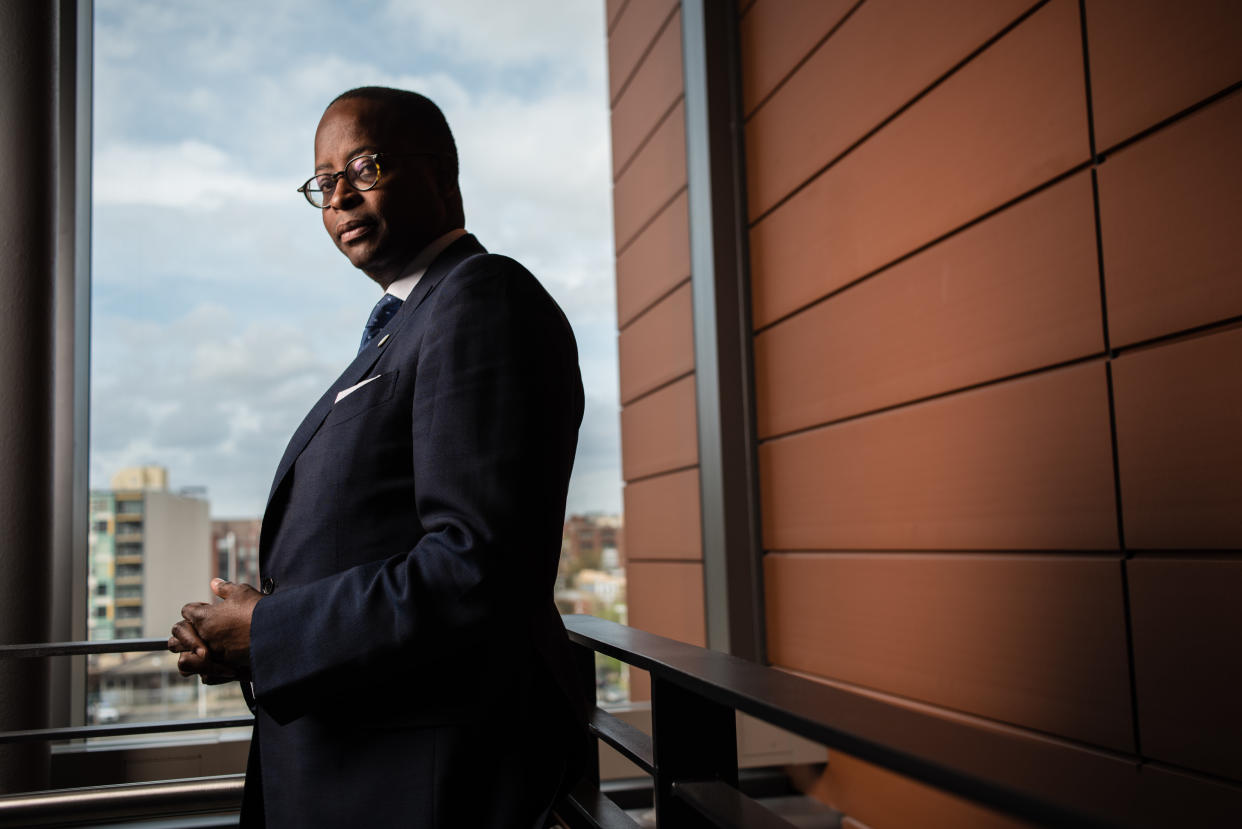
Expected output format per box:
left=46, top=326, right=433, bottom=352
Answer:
left=735, top=0, right=1242, bottom=829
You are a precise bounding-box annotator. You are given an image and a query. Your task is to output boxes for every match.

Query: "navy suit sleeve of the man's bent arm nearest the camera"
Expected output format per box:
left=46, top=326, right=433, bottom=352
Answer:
left=251, top=256, right=582, bottom=722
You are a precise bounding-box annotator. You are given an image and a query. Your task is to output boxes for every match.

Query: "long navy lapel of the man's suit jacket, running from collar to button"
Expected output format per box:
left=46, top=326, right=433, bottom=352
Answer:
left=267, top=234, right=487, bottom=506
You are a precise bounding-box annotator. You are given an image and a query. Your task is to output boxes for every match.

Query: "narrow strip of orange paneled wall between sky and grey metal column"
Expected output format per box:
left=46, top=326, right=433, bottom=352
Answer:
left=606, top=0, right=705, bottom=698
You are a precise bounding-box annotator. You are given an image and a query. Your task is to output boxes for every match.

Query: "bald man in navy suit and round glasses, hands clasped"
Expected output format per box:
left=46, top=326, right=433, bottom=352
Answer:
left=169, top=87, right=589, bottom=829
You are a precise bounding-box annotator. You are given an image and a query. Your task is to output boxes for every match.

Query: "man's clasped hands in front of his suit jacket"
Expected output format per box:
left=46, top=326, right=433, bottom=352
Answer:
left=168, top=579, right=263, bottom=685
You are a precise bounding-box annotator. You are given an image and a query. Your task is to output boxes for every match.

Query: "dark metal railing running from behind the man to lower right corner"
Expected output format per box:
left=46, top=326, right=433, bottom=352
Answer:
left=558, top=616, right=1242, bottom=829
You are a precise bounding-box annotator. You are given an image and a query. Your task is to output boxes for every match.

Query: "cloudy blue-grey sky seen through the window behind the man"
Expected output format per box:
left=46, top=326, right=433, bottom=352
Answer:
left=91, top=0, right=621, bottom=517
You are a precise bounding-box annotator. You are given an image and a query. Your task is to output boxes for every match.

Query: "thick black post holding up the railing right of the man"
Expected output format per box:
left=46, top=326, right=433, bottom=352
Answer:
left=651, top=675, right=738, bottom=829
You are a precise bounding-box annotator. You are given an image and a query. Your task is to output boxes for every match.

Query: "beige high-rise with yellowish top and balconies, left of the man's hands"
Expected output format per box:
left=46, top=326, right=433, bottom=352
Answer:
left=87, top=466, right=211, bottom=639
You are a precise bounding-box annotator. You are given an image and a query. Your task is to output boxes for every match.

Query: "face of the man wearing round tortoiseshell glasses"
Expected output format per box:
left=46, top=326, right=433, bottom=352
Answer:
left=314, top=98, right=452, bottom=287
